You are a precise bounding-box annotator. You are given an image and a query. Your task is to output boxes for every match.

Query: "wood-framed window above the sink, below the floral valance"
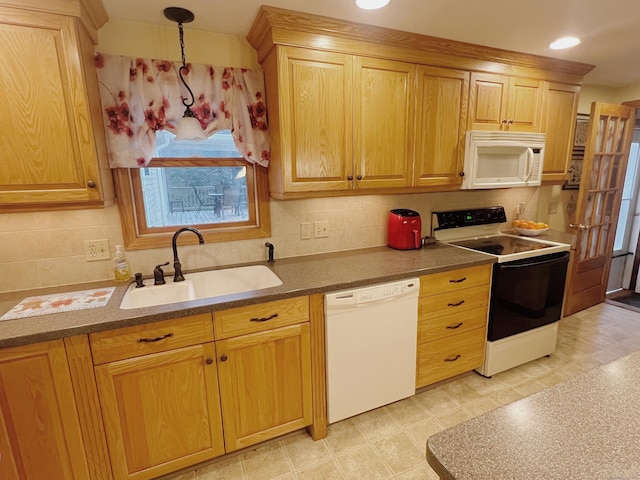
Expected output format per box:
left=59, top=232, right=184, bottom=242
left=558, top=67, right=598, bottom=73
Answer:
left=114, top=131, right=271, bottom=250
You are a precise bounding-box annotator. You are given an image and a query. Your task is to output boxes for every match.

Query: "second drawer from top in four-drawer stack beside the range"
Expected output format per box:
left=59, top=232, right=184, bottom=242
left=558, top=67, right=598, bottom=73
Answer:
left=418, top=285, right=489, bottom=320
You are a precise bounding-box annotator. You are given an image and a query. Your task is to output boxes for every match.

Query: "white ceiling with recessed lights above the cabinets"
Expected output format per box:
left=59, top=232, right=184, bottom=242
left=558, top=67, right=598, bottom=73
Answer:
left=103, top=0, right=640, bottom=88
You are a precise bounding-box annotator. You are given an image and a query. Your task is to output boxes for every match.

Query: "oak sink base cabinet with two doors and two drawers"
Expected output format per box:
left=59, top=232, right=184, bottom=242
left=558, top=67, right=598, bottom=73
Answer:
left=90, top=297, right=324, bottom=480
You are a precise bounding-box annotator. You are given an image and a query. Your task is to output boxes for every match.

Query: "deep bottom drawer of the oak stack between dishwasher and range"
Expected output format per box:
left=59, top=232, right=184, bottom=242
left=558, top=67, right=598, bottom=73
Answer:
left=416, top=328, right=486, bottom=388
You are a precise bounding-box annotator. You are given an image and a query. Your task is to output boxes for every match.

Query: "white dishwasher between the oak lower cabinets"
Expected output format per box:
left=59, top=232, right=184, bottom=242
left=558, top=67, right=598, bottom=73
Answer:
left=325, top=278, right=420, bottom=423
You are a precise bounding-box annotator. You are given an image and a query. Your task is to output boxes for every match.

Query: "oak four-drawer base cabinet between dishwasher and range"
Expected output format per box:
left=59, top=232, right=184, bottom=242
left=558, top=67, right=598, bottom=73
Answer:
left=416, top=265, right=492, bottom=388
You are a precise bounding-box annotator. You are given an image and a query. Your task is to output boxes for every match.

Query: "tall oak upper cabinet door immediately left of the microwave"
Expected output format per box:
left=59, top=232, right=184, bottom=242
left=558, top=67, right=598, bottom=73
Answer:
left=413, top=67, right=469, bottom=186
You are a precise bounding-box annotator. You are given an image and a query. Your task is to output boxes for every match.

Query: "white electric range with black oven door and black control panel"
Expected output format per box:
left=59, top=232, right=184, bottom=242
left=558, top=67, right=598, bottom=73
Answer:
left=431, top=206, right=571, bottom=377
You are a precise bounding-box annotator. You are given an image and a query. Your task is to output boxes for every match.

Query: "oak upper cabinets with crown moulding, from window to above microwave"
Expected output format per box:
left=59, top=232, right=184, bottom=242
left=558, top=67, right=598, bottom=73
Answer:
left=247, top=5, right=594, bottom=199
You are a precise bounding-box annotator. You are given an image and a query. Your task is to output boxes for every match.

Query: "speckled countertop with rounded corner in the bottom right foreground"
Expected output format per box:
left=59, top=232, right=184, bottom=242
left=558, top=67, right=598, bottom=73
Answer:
left=427, top=352, right=640, bottom=480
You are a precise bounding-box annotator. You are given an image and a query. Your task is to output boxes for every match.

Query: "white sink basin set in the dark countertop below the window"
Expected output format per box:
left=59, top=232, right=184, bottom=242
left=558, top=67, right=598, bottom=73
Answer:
left=120, top=265, right=282, bottom=309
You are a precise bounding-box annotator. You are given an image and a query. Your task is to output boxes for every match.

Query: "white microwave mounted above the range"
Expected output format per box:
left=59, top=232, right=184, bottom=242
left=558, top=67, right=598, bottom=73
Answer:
left=461, top=130, right=545, bottom=190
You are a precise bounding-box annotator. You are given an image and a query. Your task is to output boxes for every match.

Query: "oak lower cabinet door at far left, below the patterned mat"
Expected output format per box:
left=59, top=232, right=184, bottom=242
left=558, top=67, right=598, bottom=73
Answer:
left=0, top=340, right=90, bottom=480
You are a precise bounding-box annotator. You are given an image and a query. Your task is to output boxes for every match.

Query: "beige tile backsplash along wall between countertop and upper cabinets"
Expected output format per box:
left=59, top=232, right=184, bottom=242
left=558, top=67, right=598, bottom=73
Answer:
left=0, top=188, right=539, bottom=292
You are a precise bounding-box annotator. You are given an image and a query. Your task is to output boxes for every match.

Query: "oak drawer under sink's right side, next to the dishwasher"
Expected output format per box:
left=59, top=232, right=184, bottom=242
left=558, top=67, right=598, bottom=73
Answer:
left=213, top=297, right=309, bottom=340
